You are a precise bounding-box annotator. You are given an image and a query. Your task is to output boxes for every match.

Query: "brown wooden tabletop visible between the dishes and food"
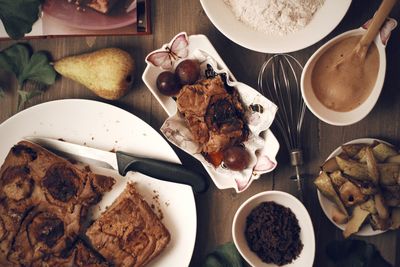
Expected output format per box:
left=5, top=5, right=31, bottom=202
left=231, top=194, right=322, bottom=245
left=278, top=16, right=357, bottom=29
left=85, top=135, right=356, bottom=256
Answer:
left=0, top=0, right=400, bottom=266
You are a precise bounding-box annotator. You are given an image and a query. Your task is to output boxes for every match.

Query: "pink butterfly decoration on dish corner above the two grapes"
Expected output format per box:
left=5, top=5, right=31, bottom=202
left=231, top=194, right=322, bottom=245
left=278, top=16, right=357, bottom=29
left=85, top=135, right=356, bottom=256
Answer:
left=145, top=32, right=189, bottom=69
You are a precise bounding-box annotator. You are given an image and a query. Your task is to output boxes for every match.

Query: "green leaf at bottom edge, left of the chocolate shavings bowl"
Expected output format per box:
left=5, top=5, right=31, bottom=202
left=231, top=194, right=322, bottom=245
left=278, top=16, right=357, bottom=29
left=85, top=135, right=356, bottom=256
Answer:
left=203, top=242, right=243, bottom=267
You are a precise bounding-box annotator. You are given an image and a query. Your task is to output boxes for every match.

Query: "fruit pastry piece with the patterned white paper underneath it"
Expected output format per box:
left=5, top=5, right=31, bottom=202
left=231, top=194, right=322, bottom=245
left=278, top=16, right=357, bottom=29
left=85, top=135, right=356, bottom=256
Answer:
left=160, top=49, right=279, bottom=192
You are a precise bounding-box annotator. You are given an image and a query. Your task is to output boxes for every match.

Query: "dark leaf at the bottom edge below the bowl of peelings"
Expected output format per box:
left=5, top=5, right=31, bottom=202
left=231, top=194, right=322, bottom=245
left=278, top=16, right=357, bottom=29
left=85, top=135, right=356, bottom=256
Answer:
left=326, top=239, right=391, bottom=267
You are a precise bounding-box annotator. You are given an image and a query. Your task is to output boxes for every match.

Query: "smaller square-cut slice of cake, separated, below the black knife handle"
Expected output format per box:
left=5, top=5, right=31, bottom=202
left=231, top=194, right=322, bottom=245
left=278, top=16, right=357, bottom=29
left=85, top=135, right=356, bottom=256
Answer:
left=86, top=184, right=170, bottom=267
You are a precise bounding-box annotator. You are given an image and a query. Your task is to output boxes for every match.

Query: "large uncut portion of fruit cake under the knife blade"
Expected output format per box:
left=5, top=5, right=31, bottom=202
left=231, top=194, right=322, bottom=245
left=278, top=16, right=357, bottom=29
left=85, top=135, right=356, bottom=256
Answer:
left=0, top=141, right=115, bottom=266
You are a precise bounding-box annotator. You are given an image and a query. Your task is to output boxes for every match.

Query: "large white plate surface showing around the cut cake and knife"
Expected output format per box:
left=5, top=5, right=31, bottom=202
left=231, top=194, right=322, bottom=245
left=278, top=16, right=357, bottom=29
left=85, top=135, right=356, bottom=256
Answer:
left=0, top=99, right=197, bottom=267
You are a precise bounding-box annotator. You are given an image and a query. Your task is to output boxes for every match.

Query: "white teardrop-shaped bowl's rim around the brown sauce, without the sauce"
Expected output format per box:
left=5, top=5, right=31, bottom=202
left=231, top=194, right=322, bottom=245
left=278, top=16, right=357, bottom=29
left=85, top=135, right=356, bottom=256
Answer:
left=301, top=28, right=386, bottom=126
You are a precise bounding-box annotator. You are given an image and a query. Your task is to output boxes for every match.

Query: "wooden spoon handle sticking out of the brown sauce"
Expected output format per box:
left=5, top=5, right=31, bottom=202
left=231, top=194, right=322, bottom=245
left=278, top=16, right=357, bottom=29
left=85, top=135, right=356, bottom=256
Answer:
left=353, top=0, right=397, bottom=61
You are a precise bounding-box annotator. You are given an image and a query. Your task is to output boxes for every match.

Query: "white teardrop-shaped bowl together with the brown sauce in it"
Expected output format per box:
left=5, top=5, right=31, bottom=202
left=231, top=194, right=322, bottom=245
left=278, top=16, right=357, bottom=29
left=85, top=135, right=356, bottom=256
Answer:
left=301, top=28, right=386, bottom=126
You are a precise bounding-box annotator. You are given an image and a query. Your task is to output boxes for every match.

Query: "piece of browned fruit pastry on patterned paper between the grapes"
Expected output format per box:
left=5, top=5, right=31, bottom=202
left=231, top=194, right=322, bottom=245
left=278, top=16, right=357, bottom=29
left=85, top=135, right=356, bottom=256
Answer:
left=176, top=75, right=248, bottom=153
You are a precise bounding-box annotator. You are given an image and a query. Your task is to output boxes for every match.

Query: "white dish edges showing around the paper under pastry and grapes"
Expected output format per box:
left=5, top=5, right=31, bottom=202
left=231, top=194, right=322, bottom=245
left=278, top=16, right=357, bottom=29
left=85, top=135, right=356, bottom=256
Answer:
left=142, top=35, right=279, bottom=192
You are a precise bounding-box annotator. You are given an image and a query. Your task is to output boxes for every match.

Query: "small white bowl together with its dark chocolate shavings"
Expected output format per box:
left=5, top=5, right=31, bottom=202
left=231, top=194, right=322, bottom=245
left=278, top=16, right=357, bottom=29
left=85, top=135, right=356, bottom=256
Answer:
left=232, top=191, right=315, bottom=267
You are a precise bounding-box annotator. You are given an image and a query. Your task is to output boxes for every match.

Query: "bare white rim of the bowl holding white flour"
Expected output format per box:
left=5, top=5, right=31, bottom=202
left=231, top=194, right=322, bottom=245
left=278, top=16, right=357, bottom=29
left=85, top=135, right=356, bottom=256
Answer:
left=200, top=0, right=351, bottom=53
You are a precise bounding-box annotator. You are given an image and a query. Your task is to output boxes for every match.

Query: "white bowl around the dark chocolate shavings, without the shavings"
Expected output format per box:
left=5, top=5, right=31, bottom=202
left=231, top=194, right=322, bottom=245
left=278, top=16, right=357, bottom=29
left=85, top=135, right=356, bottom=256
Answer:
left=232, top=191, right=315, bottom=267
